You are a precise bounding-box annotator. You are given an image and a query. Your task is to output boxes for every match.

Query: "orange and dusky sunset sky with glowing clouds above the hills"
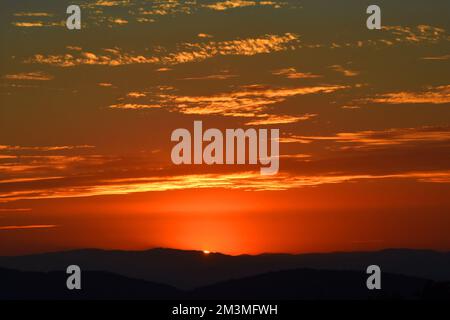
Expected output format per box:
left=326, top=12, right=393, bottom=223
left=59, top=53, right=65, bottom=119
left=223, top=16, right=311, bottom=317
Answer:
left=0, top=0, right=450, bottom=255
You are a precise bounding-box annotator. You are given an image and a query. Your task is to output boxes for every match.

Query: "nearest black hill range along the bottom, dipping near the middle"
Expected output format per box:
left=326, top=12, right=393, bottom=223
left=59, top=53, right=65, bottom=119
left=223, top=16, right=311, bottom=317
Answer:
left=0, top=268, right=450, bottom=300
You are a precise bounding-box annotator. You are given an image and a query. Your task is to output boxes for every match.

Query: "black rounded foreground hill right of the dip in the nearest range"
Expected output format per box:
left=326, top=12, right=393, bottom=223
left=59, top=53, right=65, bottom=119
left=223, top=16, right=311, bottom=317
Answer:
left=192, top=269, right=432, bottom=300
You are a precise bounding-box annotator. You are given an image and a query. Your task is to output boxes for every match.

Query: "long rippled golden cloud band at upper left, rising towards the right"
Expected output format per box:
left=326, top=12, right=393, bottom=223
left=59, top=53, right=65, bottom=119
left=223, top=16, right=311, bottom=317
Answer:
left=25, top=33, right=298, bottom=67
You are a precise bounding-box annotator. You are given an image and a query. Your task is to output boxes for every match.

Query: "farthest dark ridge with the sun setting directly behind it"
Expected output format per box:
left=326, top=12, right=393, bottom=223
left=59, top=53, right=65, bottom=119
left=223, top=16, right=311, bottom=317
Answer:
left=0, top=248, right=450, bottom=289
